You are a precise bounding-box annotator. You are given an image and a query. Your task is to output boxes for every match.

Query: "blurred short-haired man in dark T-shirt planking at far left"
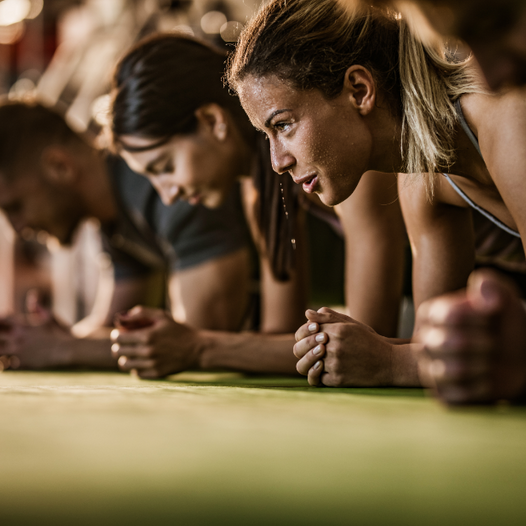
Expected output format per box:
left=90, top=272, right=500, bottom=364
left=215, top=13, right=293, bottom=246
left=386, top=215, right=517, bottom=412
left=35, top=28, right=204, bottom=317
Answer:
left=0, top=101, right=251, bottom=368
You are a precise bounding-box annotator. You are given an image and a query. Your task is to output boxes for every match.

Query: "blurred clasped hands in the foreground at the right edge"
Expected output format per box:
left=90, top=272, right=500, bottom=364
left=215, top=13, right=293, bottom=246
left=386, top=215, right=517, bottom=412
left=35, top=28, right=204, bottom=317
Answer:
left=414, top=270, right=526, bottom=404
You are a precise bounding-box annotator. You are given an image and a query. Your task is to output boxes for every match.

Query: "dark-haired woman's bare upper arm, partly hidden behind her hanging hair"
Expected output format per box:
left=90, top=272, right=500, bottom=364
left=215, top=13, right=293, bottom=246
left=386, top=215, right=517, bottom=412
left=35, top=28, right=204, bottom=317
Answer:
left=243, top=179, right=307, bottom=333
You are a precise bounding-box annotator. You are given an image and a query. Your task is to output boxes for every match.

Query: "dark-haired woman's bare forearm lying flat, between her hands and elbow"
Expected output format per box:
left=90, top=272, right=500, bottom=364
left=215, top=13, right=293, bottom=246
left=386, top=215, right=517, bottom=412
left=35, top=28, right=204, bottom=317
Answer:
left=199, top=331, right=298, bottom=375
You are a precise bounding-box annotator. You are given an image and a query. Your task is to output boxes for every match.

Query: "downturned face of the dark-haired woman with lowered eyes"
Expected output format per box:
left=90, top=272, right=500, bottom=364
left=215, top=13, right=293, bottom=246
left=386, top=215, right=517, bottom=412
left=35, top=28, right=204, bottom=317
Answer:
left=119, top=109, right=240, bottom=208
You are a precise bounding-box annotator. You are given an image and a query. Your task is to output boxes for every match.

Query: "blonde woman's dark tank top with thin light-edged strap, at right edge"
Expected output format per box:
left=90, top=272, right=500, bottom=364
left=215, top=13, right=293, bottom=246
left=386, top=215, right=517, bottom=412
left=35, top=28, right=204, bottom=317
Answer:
left=443, top=99, right=526, bottom=273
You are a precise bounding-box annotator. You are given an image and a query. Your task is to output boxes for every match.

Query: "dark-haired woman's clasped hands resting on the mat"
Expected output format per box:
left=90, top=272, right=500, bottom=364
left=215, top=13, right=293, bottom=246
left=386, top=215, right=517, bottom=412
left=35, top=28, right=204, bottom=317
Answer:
left=111, top=307, right=201, bottom=379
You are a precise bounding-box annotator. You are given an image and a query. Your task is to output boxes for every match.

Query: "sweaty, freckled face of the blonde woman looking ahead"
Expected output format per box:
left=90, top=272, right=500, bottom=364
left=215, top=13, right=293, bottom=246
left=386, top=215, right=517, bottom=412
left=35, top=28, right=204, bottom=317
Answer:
left=238, top=76, right=372, bottom=206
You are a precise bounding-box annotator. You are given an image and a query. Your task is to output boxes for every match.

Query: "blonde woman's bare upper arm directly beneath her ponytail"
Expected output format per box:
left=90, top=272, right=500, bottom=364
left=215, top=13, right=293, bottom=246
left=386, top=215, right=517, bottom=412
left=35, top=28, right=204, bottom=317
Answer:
left=399, top=175, right=475, bottom=309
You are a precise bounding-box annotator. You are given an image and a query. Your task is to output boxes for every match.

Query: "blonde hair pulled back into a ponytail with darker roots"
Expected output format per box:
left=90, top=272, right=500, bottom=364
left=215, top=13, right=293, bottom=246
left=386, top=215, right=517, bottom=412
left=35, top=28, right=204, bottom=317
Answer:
left=226, top=0, right=481, bottom=195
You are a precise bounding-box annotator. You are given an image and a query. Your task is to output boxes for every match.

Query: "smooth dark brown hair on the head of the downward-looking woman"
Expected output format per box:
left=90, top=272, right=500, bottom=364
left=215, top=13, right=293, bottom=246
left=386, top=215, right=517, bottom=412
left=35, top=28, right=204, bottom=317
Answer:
left=110, top=34, right=251, bottom=149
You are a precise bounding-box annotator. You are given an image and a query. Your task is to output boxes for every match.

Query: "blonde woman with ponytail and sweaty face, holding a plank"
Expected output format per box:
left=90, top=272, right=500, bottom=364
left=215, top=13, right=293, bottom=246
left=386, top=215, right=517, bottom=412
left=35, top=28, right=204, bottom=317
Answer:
left=229, top=0, right=526, bottom=400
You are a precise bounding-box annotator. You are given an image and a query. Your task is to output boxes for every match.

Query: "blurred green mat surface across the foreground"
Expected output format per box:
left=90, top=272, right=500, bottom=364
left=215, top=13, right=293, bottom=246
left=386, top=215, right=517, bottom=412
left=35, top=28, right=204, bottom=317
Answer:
left=0, top=372, right=526, bottom=526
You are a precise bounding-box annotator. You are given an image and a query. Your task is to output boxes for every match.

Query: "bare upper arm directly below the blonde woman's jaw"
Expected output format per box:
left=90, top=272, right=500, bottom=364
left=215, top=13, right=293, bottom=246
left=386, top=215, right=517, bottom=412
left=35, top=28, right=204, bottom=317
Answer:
left=336, top=172, right=407, bottom=336
